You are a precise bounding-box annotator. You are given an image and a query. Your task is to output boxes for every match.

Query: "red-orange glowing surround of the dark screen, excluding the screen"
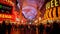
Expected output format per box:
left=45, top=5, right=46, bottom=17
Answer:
left=0, top=0, right=17, bottom=22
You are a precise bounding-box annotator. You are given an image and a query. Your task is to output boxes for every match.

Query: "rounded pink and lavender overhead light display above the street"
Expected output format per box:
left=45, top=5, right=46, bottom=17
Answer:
left=22, top=6, right=37, bottom=20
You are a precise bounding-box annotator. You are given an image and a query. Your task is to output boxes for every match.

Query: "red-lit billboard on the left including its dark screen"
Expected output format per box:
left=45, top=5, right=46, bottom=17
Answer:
left=0, top=1, right=17, bottom=22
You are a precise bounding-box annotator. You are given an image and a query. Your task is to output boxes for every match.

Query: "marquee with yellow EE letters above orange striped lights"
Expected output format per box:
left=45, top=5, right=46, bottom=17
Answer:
left=44, top=0, right=60, bottom=19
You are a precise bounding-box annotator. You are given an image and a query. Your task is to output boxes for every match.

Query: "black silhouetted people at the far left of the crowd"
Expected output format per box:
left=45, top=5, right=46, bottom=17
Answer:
left=0, top=21, right=12, bottom=34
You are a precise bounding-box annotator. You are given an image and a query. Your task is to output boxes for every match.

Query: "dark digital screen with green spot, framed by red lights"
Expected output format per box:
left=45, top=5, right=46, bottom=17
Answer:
left=0, top=3, right=12, bottom=14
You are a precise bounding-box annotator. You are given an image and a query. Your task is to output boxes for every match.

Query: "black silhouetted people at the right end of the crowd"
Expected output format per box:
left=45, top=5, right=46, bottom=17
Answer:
left=38, top=21, right=60, bottom=34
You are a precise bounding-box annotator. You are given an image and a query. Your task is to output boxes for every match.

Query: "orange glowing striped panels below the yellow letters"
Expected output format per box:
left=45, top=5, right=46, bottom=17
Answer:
left=44, top=6, right=60, bottom=20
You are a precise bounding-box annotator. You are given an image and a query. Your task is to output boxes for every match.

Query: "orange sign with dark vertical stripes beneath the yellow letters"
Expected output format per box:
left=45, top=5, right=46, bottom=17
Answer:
left=44, top=6, right=60, bottom=19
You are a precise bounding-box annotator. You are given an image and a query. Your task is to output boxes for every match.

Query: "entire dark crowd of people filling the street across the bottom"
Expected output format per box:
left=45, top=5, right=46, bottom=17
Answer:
left=0, top=21, right=60, bottom=34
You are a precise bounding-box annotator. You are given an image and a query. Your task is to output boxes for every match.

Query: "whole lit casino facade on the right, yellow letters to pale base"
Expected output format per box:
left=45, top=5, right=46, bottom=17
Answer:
left=42, top=0, right=60, bottom=22
